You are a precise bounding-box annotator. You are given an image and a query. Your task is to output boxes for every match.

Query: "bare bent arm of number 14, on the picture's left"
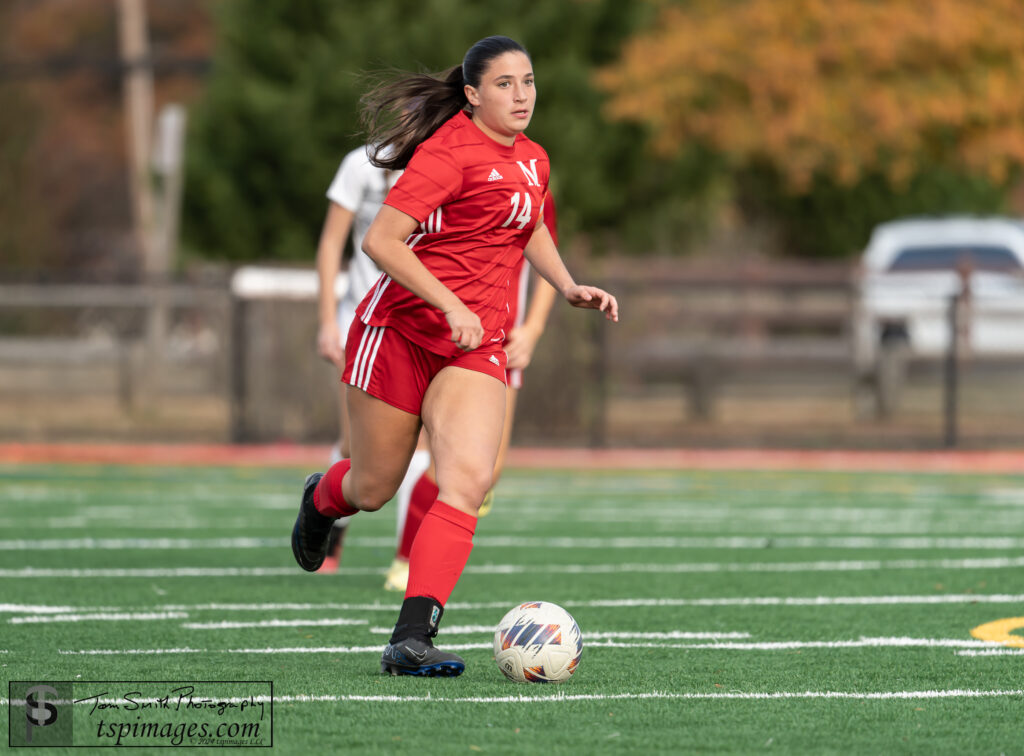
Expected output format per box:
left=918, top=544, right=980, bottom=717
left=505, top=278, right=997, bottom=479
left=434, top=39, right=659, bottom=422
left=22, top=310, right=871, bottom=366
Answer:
left=362, top=205, right=483, bottom=351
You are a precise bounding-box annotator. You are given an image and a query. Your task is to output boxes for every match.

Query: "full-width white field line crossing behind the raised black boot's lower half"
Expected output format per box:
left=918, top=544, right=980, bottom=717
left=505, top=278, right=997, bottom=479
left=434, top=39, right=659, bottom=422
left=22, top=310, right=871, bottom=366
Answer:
left=9, top=536, right=1024, bottom=551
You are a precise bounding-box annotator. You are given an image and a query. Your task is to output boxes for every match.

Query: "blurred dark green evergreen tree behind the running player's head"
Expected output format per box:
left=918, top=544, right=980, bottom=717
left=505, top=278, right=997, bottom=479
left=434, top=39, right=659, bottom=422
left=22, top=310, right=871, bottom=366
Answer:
left=184, top=0, right=708, bottom=261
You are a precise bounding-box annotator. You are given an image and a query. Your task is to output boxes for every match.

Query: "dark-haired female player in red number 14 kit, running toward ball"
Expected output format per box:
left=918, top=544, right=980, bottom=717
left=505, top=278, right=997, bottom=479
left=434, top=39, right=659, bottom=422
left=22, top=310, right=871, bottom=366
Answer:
left=292, top=37, right=618, bottom=676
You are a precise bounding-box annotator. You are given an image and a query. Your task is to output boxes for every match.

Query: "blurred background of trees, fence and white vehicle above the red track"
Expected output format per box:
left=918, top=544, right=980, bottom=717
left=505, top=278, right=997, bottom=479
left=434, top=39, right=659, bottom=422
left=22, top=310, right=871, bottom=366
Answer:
left=0, top=0, right=1024, bottom=449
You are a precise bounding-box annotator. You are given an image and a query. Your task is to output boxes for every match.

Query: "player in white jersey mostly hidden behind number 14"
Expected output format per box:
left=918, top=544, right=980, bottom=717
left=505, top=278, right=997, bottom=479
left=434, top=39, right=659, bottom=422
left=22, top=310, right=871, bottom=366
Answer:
left=316, top=146, right=430, bottom=572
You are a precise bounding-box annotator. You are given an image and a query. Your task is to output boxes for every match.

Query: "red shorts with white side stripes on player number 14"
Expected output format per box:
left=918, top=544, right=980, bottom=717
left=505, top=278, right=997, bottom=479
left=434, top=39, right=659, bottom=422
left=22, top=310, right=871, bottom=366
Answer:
left=341, top=319, right=508, bottom=415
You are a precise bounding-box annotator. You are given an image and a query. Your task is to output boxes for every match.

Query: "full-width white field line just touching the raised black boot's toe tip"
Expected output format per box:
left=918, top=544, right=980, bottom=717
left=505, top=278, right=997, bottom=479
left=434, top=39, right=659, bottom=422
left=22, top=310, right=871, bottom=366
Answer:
left=6, top=556, right=1024, bottom=580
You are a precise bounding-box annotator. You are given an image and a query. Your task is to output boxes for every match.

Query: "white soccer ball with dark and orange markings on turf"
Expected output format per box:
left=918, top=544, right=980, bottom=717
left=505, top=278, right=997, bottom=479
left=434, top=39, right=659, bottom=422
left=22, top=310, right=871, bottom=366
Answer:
left=495, top=601, right=583, bottom=682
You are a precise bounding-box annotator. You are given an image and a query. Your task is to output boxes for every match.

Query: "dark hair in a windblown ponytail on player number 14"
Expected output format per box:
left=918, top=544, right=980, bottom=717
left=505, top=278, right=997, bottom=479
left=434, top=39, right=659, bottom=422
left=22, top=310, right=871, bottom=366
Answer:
left=360, top=37, right=529, bottom=170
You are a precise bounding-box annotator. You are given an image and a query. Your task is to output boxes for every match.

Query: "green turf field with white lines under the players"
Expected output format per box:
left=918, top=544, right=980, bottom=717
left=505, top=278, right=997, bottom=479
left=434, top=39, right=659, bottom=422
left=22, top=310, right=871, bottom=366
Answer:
left=0, top=465, right=1024, bottom=754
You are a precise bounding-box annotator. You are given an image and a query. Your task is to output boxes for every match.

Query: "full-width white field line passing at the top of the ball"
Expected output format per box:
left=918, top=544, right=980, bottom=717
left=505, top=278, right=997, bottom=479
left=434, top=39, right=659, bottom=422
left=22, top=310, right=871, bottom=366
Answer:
left=6, top=593, right=1024, bottom=615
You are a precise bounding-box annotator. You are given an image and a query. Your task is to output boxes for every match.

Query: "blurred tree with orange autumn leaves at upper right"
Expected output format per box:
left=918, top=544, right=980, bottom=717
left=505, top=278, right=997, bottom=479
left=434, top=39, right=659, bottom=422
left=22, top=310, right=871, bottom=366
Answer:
left=598, top=0, right=1024, bottom=193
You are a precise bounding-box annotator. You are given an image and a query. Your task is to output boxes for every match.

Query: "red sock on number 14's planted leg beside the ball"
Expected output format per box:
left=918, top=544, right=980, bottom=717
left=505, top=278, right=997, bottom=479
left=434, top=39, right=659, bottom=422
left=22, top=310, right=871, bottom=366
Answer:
left=406, top=499, right=476, bottom=606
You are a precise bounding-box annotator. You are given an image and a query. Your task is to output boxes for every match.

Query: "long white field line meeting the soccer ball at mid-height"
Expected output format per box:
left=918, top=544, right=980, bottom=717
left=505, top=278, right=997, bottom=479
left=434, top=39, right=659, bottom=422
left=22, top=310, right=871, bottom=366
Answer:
left=57, top=637, right=998, bottom=656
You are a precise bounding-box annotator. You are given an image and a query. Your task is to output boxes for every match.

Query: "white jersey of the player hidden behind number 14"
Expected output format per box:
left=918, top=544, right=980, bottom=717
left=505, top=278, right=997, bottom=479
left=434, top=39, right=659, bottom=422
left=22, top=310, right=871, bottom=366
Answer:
left=327, top=146, right=401, bottom=309
